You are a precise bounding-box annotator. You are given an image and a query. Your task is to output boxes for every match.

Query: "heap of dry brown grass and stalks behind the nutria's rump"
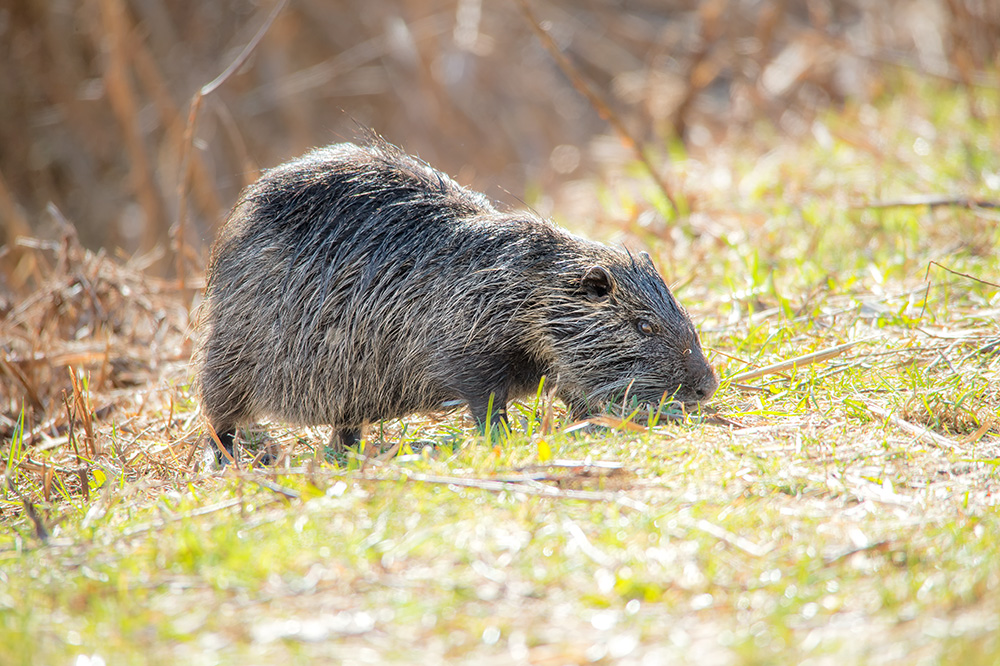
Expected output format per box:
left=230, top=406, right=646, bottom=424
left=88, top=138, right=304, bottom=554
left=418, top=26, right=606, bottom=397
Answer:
left=0, top=227, right=190, bottom=462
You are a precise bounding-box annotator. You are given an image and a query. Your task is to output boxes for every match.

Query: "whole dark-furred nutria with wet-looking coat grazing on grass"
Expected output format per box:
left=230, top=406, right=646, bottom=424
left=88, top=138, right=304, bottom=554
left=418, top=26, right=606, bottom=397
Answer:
left=196, top=140, right=718, bottom=452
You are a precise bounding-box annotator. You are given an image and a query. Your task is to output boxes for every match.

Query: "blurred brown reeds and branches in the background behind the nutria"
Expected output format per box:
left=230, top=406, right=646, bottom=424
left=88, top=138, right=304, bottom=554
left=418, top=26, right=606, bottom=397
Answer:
left=0, top=0, right=1000, bottom=280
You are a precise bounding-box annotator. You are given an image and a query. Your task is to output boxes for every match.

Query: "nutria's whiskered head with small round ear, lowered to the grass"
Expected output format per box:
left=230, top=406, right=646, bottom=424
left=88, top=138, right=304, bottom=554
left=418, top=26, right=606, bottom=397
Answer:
left=543, top=244, right=719, bottom=412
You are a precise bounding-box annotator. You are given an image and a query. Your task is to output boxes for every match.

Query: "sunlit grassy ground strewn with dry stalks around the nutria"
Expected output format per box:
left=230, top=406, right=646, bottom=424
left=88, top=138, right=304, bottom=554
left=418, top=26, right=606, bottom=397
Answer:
left=0, top=75, right=1000, bottom=665
